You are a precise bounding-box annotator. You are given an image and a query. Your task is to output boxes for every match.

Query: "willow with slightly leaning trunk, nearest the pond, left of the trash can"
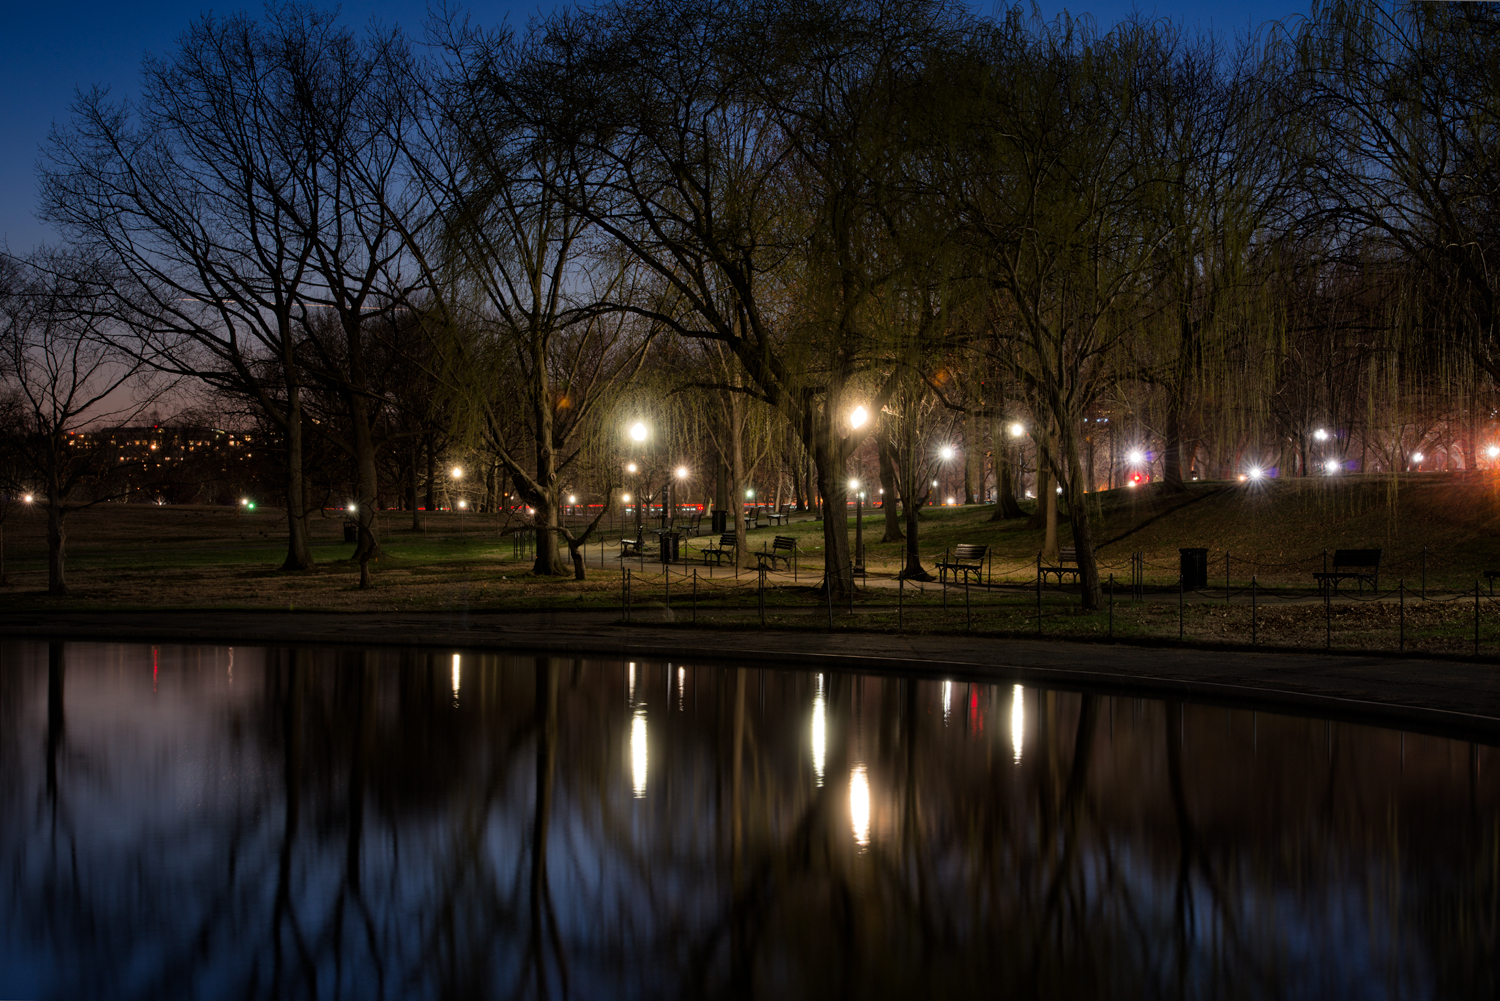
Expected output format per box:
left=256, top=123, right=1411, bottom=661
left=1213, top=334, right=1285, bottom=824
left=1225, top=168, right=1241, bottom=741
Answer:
left=932, top=12, right=1170, bottom=608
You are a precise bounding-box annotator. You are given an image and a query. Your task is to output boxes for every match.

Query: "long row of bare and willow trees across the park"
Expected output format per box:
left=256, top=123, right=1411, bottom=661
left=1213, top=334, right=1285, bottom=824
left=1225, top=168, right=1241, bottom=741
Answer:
left=0, top=0, right=1500, bottom=606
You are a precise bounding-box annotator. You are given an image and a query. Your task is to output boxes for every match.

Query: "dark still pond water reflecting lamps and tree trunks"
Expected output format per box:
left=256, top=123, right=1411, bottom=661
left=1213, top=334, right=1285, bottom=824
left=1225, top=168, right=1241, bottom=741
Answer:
left=0, top=642, right=1500, bottom=1001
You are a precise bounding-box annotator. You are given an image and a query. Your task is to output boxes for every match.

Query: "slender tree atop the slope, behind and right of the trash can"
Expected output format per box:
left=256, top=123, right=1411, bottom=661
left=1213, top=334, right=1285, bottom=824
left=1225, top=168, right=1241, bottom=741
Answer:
left=1133, top=27, right=1301, bottom=491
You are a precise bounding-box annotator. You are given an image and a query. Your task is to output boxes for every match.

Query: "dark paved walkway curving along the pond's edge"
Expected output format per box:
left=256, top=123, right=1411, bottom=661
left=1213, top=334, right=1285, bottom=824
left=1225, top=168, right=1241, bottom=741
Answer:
left=0, top=609, right=1500, bottom=741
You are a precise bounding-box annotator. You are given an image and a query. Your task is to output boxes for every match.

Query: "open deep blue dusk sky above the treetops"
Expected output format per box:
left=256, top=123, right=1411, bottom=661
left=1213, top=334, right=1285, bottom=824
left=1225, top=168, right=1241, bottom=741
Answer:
left=0, top=0, right=1307, bottom=252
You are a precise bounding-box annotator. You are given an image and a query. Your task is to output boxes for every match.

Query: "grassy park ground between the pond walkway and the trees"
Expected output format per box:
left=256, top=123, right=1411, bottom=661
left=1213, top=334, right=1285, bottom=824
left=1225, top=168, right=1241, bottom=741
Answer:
left=0, top=474, right=1500, bottom=660
